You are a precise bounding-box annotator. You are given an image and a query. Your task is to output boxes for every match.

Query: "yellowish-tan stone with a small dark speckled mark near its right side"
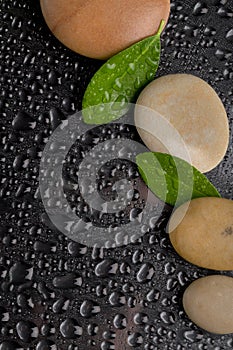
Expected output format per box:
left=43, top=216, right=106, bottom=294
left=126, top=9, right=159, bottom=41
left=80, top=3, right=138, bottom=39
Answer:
left=168, top=197, right=233, bottom=270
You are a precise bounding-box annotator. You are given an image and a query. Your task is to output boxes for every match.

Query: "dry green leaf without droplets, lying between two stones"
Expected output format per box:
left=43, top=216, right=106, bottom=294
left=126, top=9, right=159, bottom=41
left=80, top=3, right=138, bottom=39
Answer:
left=136, top=152, right=221, bottom=206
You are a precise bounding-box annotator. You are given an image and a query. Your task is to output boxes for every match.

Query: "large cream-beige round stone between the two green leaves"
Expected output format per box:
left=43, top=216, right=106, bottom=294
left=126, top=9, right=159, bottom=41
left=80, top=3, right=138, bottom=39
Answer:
left=135, top=74, right=229, bottom=172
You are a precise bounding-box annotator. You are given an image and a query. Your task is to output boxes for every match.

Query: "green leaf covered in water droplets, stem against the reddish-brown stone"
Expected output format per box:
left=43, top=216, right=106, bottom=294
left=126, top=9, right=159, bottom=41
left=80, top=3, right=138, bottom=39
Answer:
left=82, top=21, right=164, bottom=124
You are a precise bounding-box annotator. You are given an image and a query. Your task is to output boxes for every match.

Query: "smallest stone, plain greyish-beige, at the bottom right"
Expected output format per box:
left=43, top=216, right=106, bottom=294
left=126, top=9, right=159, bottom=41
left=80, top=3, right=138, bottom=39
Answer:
left=183, top=275, right=233, bottom=334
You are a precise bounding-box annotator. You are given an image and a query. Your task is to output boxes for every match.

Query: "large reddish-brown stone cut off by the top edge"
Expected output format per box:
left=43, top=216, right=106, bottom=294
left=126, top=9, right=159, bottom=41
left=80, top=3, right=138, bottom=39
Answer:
left=40, top=0, right=170, bottom=59
